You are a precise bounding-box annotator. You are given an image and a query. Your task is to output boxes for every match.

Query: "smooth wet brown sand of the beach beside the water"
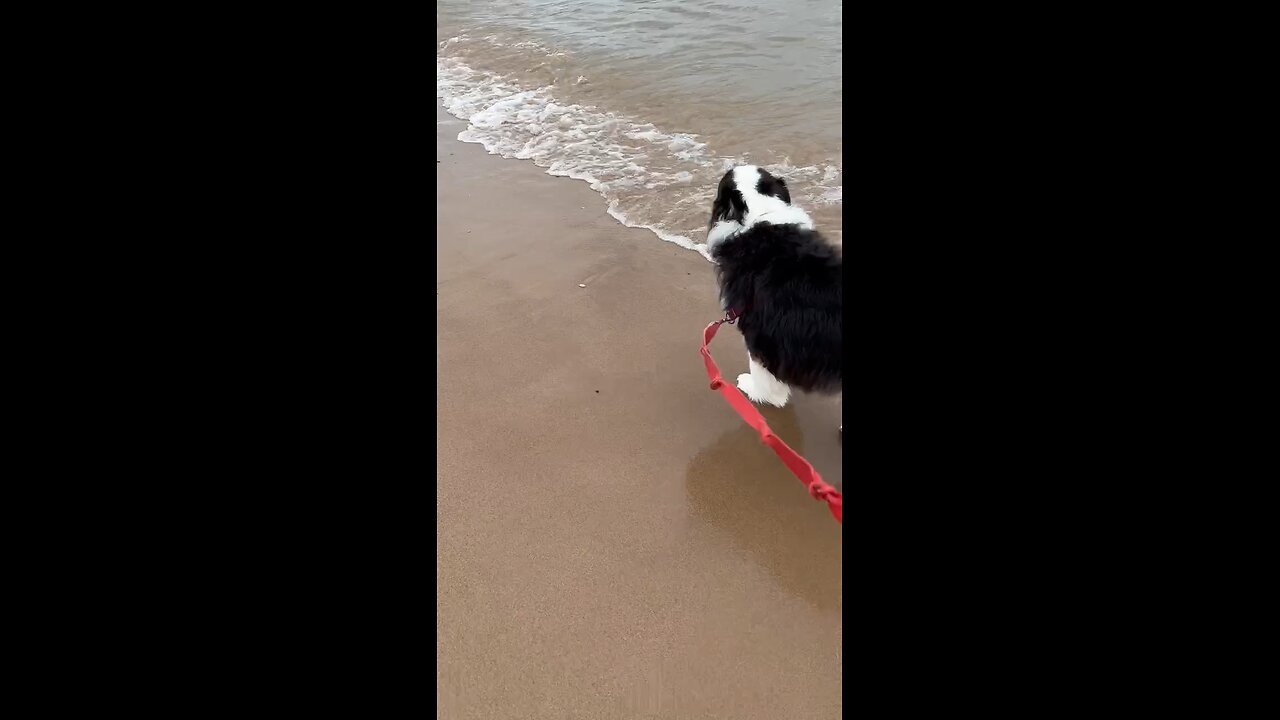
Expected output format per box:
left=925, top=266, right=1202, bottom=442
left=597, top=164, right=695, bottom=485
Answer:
left=435, top=108, right=856, bottom=720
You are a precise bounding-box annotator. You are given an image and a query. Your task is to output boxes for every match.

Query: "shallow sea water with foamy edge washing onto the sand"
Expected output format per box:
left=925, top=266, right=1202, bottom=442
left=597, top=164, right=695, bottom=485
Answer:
left=435, top=0, right=842, bottom=255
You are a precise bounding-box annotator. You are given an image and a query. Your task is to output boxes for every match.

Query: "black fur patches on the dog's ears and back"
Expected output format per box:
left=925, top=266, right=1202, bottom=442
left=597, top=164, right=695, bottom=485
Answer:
left=710, top=168, right=844, bottom=392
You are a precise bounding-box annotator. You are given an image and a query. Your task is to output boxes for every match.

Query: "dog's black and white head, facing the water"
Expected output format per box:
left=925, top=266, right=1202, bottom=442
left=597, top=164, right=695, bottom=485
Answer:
left=707, top=165, right=813, bottom=245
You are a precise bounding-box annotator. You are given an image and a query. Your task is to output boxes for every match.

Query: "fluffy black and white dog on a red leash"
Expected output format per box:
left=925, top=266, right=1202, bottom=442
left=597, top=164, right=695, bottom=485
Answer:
left=707, top=165, right=844, bottom=425
